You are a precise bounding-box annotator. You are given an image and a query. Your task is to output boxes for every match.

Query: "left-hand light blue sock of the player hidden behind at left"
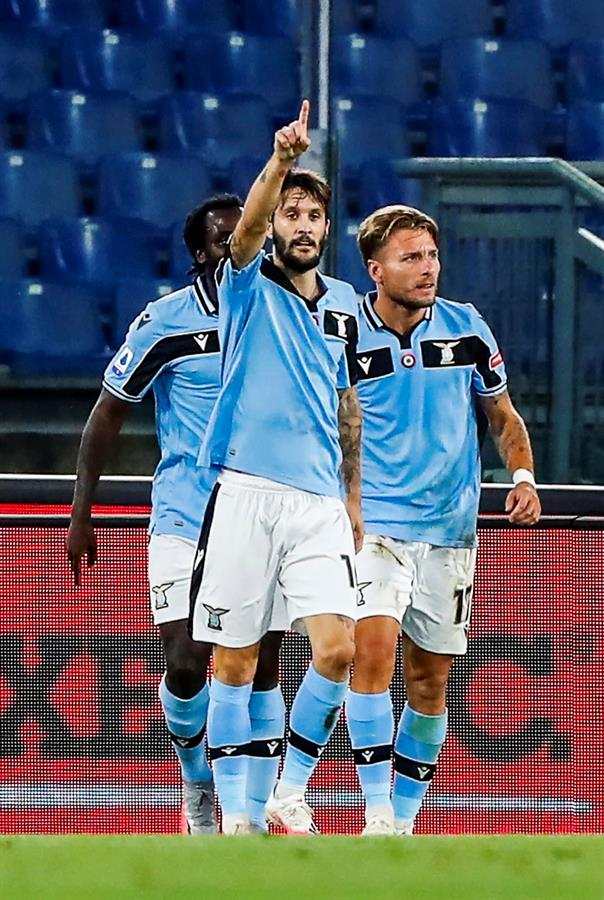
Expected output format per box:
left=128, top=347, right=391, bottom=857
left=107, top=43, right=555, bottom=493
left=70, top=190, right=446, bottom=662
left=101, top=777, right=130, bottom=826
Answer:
left=159, top=675, right=212, bottom=781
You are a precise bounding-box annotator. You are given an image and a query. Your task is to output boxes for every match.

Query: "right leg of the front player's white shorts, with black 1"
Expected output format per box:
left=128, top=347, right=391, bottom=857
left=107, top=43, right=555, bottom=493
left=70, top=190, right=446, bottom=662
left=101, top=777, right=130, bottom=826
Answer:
left=279, top=494, right=357, bottom=630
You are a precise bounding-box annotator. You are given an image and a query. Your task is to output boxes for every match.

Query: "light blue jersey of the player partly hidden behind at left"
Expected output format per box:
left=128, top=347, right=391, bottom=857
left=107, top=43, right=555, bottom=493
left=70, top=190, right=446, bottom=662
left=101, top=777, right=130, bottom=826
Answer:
left=103, top=276, right=220, bottom=541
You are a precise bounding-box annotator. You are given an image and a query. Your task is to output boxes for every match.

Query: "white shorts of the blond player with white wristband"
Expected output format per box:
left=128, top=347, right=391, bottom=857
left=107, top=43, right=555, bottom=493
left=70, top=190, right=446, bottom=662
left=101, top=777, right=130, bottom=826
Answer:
left=356, top=534, right=476, bottom=656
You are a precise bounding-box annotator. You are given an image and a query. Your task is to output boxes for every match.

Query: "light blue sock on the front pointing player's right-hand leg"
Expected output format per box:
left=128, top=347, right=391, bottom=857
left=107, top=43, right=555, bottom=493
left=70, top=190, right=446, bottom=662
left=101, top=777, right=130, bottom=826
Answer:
left=279, top=663, right=348, bottom=794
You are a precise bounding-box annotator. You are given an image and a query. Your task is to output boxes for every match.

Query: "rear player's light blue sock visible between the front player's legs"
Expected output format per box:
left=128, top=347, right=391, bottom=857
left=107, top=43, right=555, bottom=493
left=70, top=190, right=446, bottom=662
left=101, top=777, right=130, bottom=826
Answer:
left=247, top=687, right=285, bottom=829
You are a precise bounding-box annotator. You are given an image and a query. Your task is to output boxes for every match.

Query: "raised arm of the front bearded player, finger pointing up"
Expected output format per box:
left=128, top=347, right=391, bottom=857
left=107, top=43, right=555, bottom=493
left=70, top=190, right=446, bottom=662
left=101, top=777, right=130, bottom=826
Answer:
left=230, top=100, right=310, bottom=269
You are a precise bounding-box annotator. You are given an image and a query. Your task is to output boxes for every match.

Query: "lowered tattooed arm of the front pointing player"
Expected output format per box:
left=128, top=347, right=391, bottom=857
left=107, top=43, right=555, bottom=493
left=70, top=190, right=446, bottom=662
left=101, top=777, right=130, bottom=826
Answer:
left=338, top=387, right=363, bottom=553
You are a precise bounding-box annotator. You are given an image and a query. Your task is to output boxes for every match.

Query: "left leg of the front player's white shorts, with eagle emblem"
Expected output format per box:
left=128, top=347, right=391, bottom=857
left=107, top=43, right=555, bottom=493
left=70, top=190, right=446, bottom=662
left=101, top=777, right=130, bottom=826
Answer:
left=190, top=483, right=278, bottom=648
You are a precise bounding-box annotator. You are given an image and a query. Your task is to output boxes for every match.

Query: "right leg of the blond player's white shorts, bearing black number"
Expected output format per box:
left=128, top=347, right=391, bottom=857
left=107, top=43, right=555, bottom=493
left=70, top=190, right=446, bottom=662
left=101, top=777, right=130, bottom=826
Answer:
left=403, top=545, right=476, bottom=656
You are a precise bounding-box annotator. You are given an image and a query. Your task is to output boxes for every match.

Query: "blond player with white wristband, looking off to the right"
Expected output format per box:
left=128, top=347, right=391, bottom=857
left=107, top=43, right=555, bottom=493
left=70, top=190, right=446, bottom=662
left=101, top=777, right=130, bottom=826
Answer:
left=346, top=206, right=540, bottom=835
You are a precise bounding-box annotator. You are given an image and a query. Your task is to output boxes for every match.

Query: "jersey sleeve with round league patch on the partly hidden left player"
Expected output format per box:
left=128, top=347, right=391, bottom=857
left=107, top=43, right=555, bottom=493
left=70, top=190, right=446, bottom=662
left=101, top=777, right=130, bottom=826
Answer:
left=103, top=304, right=161, bottom=403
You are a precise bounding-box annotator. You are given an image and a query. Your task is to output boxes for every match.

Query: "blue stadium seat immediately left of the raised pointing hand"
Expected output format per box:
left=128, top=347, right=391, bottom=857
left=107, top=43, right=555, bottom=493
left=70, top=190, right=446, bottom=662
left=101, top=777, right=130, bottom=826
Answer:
left=160, top=91, right=273, bottom=171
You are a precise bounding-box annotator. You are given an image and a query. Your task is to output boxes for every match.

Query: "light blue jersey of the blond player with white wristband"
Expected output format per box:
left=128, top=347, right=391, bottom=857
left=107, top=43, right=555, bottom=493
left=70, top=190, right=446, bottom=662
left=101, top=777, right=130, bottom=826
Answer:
left=357, top=294, right=506, bottom=547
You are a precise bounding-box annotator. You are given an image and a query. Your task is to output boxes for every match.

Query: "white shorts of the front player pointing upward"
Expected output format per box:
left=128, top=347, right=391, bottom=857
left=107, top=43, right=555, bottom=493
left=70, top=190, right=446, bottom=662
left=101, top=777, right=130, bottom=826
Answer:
left=190, top=470, right=356, bottom=647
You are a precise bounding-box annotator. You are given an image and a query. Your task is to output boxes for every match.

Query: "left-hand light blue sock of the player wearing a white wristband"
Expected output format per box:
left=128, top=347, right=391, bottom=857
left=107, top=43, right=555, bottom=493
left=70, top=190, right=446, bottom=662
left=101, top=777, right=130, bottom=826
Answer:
left=346, top=691, right=394, bottom=810
